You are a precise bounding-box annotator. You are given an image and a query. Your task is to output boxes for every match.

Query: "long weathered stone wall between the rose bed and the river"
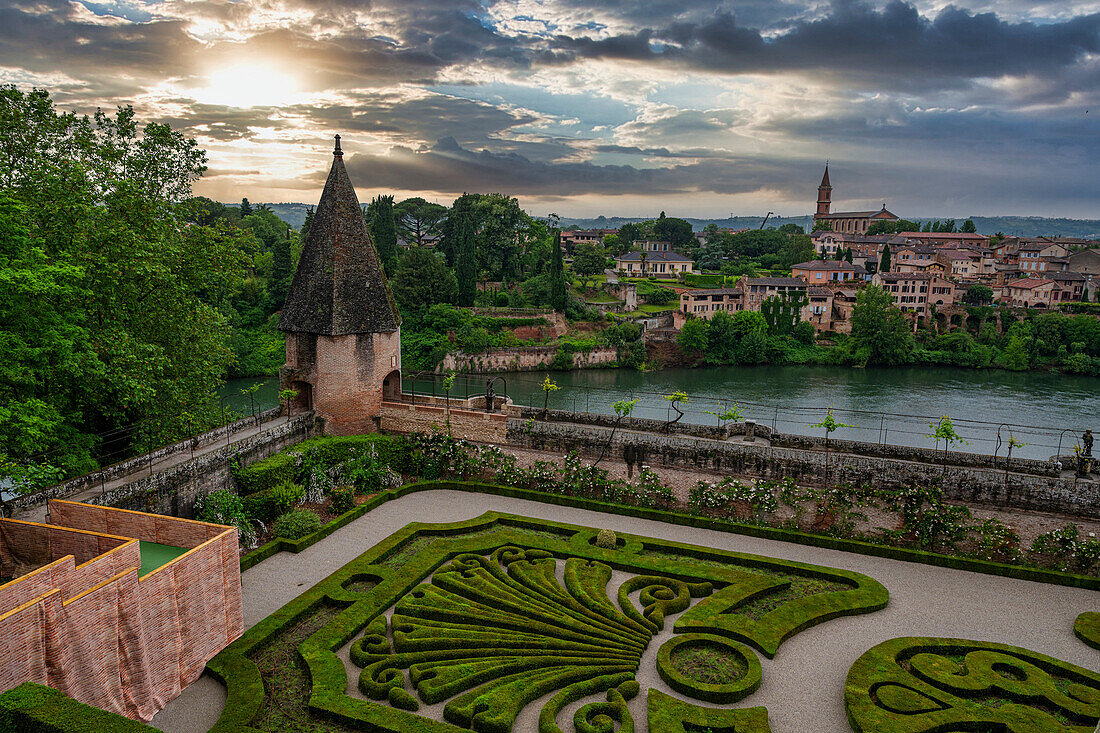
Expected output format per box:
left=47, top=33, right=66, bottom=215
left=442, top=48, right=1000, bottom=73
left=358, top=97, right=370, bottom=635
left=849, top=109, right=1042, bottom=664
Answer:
left=507, top=411, right=1100, bottom=518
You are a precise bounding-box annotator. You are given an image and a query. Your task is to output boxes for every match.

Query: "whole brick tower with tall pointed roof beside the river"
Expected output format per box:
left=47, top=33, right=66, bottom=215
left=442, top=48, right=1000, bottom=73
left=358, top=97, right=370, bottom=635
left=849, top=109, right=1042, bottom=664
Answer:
left=278, top=135, right=402, bottom=435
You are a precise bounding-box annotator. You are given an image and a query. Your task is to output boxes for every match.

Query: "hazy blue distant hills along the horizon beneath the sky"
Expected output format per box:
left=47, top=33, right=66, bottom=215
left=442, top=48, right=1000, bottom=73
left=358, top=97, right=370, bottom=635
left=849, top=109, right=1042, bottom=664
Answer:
left=227, top=203, right=1100, bottom=239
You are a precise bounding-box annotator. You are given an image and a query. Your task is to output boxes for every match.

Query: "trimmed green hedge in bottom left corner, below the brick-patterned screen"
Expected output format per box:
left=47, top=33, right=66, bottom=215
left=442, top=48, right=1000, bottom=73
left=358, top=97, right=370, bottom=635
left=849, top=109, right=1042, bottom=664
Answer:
left=0, top=682, right=156, bottom=733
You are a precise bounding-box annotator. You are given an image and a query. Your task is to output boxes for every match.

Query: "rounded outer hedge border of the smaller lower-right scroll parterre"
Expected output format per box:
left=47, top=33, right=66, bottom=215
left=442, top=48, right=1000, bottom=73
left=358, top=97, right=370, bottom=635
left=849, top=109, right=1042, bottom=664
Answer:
left=844, top=636, right=1100, bottom=733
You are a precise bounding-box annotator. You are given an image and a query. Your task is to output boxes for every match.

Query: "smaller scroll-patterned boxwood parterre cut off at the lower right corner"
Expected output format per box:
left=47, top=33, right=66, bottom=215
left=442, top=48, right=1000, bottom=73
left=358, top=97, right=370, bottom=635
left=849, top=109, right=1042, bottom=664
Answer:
left=845, top=637, right=1100, bottom=733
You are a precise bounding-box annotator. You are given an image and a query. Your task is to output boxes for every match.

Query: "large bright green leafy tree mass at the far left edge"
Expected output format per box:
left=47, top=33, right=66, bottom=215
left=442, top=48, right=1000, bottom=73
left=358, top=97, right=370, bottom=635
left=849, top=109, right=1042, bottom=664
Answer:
left=0, top=86, right=254, bottom=474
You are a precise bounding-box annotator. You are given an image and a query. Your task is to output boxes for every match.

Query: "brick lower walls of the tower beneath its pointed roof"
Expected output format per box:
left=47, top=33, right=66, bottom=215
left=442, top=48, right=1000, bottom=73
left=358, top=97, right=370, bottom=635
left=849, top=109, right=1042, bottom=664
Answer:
left=305, top=329, right=402, bottom=435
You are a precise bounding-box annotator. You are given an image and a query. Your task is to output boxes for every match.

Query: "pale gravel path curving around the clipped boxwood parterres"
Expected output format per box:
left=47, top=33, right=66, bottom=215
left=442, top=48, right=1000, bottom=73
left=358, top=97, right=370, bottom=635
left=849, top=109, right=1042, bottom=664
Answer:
left=152, top=491, right=1100, bottom=733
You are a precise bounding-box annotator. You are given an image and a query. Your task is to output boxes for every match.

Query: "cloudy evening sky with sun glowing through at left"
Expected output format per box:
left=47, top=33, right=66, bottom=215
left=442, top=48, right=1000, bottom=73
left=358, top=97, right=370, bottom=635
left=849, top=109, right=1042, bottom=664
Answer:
left=0, top=0, right=1100, bottom=218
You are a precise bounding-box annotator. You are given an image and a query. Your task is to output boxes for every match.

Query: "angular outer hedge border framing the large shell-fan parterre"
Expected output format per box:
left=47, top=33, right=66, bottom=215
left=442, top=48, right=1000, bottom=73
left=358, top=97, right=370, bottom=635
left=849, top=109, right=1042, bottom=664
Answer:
left=208, top=506, right=888, bottom=733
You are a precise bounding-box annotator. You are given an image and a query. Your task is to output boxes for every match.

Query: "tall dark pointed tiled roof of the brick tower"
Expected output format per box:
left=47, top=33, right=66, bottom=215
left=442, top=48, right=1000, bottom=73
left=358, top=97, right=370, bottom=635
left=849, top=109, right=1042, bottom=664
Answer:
left=278, top=135, right=402, bottom=336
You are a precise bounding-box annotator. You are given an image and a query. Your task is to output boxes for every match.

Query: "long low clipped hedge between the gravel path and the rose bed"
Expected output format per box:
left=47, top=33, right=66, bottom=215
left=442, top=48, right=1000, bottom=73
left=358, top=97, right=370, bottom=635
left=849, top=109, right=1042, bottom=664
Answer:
left=241, top=480, right=1100, bottom=590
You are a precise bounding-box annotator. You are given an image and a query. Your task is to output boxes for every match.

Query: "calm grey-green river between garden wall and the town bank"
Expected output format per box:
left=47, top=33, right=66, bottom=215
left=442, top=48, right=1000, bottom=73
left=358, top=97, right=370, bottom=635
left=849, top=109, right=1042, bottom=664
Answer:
left=219, top=367, right=1100, bottom=459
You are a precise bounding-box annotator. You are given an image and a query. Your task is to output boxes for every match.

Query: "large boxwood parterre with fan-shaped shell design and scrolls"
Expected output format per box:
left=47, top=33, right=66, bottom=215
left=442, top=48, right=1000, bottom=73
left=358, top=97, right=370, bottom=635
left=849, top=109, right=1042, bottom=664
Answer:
left=209, top=513, right=888, bottom=733
